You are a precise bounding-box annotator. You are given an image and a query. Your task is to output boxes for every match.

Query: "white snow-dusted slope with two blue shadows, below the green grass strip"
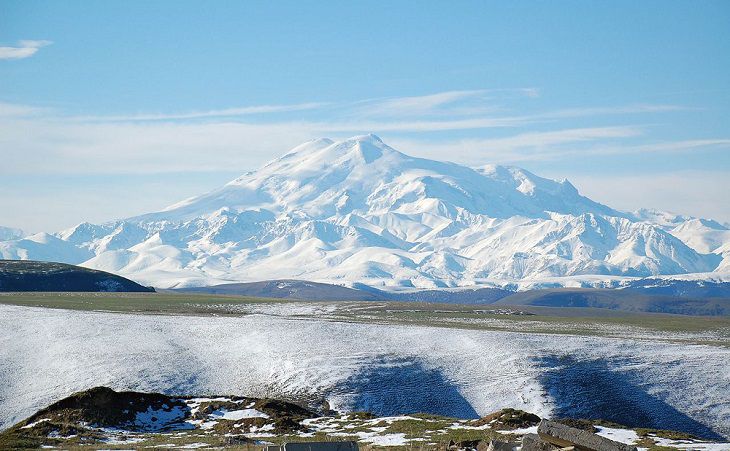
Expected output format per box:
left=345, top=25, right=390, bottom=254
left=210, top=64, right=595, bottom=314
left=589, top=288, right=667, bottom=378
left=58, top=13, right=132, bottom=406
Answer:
left=0, top=305, right=730, bottom=438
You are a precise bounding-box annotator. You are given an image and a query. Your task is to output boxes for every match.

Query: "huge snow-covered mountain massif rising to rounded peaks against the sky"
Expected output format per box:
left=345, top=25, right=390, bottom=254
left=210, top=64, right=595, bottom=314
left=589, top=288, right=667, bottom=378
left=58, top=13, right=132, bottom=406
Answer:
left=0, top=135, right=730, bottom=288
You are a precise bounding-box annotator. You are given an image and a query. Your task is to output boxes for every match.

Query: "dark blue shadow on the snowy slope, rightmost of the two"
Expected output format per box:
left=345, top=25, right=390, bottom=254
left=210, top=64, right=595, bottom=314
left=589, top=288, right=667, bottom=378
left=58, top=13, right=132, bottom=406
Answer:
left=539, top=356, right=723, bottom=440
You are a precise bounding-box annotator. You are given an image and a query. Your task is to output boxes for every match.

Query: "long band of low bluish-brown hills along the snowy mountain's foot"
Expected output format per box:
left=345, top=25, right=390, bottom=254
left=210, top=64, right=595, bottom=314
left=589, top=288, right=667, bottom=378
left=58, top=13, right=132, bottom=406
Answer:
left=174, top=279, right=730, bottom=316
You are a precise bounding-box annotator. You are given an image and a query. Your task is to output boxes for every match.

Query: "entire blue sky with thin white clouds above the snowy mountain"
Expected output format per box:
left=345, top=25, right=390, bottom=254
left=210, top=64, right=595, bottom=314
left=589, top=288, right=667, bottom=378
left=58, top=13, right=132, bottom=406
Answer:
left=0, top=0, right=730, bottom=231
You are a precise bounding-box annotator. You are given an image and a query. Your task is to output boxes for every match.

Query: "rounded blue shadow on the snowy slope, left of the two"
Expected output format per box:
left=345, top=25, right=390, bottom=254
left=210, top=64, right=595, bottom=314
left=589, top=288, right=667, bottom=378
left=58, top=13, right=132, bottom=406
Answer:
left=336, top=358, right=479, bottom=418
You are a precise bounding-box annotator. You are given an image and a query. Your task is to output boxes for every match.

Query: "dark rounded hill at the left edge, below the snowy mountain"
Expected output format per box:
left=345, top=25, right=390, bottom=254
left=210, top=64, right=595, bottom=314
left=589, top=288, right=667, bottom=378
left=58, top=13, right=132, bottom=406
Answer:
left=0, top=260, right=155, bottom=292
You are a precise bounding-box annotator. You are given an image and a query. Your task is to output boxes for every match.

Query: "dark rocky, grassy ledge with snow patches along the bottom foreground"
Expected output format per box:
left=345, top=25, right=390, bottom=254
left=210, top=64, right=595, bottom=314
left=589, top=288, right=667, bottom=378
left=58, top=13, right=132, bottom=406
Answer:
left=0, top=387, right=730, bottom=451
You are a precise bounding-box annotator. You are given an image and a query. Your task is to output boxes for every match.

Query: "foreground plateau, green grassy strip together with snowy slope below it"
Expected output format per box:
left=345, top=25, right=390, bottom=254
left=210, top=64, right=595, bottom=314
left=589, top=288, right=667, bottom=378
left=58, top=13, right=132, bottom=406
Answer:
left=0, top=293, right=730, bottom=440
